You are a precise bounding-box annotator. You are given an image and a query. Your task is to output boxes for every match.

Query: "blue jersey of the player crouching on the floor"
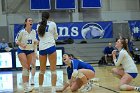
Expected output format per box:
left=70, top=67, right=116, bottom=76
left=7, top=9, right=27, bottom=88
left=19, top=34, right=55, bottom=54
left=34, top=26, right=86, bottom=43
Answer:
left=67, top=59, right=95, bottom=80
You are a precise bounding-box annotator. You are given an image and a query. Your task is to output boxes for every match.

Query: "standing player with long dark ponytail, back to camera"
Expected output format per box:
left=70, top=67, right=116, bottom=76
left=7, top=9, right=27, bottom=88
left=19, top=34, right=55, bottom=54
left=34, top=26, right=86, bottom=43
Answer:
left=37, top=12, right=58, bottom=92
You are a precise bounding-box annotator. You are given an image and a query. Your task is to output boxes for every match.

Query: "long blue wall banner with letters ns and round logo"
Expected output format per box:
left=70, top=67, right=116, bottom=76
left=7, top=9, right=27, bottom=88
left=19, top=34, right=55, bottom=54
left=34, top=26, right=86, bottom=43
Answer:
left=14, top=21, right=113, bottom=40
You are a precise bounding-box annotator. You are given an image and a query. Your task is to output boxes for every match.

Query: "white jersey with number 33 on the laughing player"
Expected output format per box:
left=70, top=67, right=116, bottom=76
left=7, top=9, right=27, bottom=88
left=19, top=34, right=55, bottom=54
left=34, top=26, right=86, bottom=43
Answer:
left=15, top=29, right=37, bottom=50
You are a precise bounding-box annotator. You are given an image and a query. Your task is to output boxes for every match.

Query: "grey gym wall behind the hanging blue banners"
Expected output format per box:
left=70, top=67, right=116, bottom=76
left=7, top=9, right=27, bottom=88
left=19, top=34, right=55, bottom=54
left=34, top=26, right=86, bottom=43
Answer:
left=0, top=0, right=140, bottom=42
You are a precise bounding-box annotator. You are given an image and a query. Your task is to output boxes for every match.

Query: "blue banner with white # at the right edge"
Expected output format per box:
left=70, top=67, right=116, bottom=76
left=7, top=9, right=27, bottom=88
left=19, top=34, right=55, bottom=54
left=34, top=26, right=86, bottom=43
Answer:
left=128, top=20, right=140, bottom=38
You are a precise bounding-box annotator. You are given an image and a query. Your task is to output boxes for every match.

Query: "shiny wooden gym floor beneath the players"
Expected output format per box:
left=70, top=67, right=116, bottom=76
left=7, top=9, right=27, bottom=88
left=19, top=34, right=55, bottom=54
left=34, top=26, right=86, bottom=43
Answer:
left=0, top=65, right=140, bottom=93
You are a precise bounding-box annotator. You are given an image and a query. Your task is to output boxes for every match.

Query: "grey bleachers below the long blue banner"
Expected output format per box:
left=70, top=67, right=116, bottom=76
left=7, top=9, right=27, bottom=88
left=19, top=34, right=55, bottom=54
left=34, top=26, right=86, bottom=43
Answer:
left=57, top=38, right=115, bottom=64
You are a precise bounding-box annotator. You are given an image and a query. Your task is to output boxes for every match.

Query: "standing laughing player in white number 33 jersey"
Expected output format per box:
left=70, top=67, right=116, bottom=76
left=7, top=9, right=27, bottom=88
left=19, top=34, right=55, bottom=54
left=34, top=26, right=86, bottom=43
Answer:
left=15, top=18, right=37, bottom=92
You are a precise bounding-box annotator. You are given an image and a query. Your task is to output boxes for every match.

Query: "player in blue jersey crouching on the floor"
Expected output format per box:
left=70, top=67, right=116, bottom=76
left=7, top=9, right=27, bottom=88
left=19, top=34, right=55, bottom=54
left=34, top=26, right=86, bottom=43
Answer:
left=57, top=54, right=95, bottom=92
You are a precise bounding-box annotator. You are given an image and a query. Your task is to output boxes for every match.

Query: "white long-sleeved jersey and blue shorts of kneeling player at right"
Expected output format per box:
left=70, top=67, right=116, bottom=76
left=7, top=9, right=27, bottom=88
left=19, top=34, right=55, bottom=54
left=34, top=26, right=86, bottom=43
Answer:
left=114, top=49, right=138, bottom=78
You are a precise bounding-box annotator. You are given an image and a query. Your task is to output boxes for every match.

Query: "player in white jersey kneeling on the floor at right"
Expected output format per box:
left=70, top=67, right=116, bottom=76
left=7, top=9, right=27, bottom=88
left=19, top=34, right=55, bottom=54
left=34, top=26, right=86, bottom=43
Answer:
left=112, top=38, right=140, bottom=91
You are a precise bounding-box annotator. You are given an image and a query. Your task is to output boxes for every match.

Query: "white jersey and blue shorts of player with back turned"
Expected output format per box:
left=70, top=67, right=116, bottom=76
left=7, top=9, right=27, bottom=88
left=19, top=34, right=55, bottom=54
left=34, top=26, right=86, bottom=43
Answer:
left=37, top=21, right=58, bottom=55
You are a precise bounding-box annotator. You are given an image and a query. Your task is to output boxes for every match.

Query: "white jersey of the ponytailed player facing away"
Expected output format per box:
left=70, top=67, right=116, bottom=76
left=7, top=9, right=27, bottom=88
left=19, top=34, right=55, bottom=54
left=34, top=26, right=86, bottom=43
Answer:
left=37, top=21, right=58, bottom=50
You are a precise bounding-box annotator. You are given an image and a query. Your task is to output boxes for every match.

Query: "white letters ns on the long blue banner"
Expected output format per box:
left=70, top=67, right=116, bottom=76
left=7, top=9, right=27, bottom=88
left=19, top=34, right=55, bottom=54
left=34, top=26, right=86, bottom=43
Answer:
left=58, top=27, right=79, bottom=36
